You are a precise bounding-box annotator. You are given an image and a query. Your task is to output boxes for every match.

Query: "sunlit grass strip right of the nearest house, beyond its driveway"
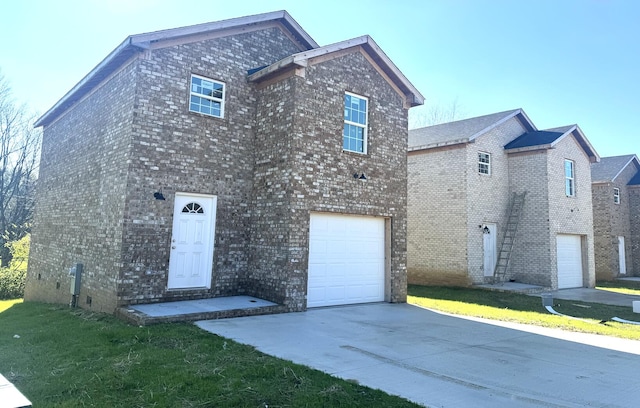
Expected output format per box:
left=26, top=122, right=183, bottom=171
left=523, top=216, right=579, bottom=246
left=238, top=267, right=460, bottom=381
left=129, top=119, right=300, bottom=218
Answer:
left=407, top=283, right=640, bottom=340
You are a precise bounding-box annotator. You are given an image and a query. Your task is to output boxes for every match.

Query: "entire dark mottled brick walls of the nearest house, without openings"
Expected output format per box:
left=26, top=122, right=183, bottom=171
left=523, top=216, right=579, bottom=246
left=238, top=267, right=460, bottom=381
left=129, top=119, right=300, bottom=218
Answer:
left=25, top=27, right=407, bottom=312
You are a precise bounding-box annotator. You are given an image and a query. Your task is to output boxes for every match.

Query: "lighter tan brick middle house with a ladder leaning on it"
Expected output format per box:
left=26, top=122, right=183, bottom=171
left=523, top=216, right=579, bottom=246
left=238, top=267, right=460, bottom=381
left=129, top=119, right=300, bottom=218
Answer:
left=407, top=109, right=599, bottom=289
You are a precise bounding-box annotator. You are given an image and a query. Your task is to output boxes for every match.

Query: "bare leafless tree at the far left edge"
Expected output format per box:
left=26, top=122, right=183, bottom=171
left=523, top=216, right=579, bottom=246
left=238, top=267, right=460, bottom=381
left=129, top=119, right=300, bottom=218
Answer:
left=0, top=73, right=40, bottom=267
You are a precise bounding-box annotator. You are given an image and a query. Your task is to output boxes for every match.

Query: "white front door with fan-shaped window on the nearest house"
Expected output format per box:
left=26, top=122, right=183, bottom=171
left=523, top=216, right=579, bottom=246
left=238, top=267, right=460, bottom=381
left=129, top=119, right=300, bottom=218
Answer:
left=167, top=193, right=216, bottom=289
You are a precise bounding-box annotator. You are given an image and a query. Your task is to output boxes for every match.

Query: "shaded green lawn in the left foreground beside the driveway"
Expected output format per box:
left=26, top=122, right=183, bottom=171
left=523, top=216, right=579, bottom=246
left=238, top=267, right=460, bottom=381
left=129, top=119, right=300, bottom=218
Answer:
left=0, top=301, right=417, bottom=408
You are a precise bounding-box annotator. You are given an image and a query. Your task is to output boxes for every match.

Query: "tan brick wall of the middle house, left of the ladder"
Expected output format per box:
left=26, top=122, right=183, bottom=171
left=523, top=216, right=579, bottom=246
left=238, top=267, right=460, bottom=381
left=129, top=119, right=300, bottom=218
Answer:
left=407, top=118, right=525, bottom=286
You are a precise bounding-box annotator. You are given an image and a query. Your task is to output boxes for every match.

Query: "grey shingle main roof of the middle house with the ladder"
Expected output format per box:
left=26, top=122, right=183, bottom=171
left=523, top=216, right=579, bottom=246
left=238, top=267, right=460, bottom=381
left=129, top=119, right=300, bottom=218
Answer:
left=409, top=109, right=535, bottom=151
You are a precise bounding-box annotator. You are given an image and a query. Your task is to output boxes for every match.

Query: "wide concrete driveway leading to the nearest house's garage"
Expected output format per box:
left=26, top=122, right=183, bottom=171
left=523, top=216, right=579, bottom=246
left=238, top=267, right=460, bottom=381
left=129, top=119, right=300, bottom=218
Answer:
left=196, top=303, right=640, bottom=408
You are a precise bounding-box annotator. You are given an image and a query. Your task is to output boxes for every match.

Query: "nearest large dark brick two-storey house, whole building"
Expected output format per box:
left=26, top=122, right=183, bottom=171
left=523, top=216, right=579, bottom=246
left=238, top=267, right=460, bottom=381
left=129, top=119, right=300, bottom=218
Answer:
left=25, top=11, right=424, bottom=312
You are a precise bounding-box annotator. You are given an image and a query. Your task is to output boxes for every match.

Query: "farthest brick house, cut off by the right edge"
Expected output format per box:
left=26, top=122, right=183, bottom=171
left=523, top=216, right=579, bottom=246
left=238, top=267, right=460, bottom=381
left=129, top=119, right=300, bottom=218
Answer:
left=591, top=154, right=640, bottom=280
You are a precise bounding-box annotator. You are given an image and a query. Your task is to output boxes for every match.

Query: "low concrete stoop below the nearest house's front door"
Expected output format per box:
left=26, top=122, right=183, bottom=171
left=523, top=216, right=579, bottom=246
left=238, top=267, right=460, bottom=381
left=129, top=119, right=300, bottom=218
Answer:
left=115, top=296, right=289, bottom=326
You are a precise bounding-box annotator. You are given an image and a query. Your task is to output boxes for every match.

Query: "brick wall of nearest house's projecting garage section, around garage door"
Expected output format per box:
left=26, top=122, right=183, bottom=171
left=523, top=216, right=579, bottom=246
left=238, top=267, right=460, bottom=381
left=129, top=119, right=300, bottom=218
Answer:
left=248, top=52, right=408, bottom=310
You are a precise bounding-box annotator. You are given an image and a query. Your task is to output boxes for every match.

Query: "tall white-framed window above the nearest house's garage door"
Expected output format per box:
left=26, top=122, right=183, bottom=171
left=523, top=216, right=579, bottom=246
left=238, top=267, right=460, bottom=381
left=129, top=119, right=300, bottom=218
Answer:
left=342, top=92, right=369, bottom=153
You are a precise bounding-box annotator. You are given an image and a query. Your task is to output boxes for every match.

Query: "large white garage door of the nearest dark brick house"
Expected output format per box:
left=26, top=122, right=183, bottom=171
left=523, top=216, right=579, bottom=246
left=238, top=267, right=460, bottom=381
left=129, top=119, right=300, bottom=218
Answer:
left=307, top=214, right=385, bottom=307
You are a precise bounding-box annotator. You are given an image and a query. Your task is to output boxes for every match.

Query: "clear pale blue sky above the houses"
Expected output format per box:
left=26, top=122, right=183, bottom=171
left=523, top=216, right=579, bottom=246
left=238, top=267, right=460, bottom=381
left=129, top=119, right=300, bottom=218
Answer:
left=0, top=0, right=640, bottom=156
